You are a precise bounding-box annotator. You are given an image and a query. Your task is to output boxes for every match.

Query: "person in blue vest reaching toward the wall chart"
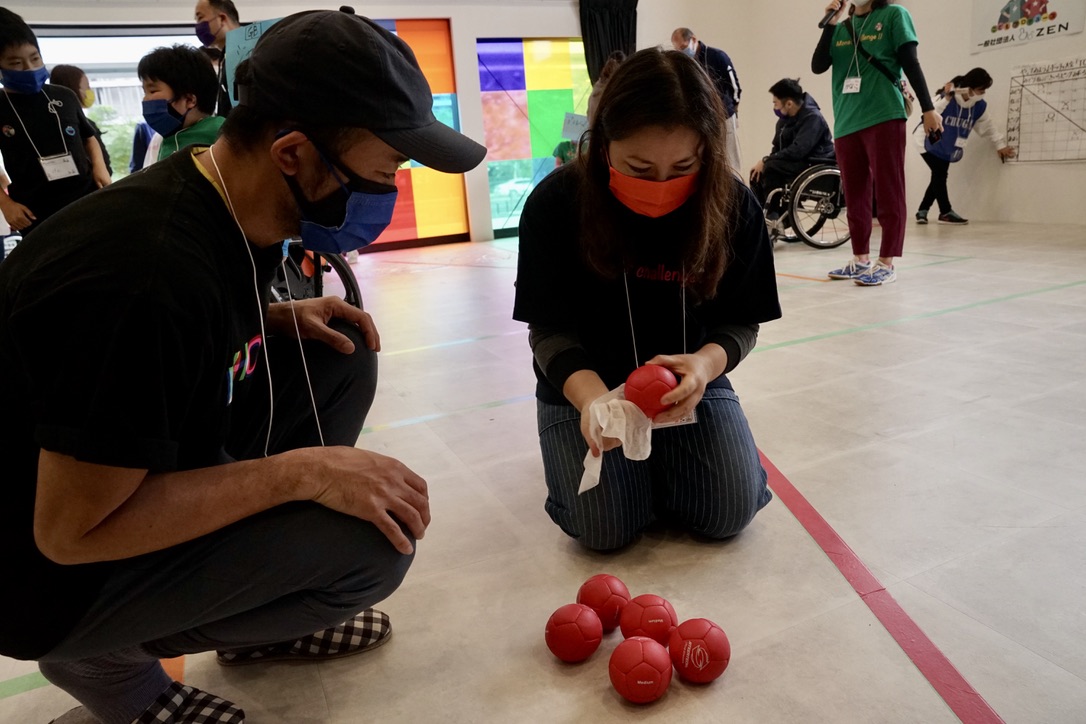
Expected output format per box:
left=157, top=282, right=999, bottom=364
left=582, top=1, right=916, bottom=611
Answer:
left=917, top=68, right=1015, bottom=226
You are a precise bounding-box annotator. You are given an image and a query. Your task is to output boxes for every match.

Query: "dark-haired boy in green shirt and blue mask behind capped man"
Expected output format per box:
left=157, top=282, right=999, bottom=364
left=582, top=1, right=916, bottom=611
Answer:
left=137, top=46, right=225, bottom=161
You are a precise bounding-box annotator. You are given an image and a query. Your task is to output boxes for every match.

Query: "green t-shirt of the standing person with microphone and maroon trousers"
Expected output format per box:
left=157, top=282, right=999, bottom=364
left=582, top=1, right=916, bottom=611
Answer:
left=830, top=5, right=917, bottom=138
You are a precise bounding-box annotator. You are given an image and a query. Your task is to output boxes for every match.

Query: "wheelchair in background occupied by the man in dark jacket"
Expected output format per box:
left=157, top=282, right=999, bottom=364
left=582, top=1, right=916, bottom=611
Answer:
left=763, top=158, right=851, bottom=249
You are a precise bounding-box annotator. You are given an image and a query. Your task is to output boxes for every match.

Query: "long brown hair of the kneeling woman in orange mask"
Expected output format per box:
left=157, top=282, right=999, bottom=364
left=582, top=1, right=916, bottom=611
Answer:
left=577, top=48, right=738, bottom=300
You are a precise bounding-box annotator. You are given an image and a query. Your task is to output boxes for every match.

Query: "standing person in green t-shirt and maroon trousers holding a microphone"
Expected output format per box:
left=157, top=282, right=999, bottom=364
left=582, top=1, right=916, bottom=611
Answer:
left=811, top=0, right=943, bottom=287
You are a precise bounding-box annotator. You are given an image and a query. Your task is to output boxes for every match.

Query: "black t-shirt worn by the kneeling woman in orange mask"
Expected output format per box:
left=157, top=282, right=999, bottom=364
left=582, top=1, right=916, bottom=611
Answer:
left=513, top=167, right=781, bottom=405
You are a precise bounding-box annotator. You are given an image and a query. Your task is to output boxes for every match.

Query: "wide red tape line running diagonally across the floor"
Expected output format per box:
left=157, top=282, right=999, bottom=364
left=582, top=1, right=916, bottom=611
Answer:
left=759, top=453, right=1003, bottom=724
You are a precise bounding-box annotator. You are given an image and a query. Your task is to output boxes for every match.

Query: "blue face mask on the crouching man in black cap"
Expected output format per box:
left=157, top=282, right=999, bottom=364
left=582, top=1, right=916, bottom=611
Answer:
left=286, top=149, right=399, bottom=254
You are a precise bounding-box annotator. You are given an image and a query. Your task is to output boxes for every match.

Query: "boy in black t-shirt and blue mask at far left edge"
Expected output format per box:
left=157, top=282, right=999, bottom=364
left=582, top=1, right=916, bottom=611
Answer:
left=0, top=8, right=110, bottom=237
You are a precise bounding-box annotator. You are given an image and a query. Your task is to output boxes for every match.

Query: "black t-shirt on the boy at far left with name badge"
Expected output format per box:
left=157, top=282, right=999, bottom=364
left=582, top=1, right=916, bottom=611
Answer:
left=0, top=84, right=98, bottom=224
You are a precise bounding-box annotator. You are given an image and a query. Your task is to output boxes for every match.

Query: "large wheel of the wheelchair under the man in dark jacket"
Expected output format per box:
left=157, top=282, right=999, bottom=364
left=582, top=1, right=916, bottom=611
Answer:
left=790, top=165, right=851, bottom=249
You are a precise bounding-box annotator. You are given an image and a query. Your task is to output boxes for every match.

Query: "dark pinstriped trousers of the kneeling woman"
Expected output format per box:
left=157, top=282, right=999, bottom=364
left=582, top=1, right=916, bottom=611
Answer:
left=536, top=389, right=773, bottom=550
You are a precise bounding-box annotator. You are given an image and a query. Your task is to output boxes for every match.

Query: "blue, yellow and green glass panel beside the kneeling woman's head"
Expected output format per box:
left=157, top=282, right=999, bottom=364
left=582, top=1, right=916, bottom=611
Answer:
left=476, top=38, right=592, bottom=236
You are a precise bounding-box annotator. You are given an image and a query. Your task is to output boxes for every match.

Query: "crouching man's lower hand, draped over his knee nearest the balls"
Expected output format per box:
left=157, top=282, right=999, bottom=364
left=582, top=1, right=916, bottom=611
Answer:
left=310, top=446, right=430, bottom=556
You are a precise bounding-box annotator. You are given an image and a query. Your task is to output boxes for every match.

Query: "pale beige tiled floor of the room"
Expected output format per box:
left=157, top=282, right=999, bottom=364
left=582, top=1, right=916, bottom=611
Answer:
left=0, top=224, right=1086, bottom=724
